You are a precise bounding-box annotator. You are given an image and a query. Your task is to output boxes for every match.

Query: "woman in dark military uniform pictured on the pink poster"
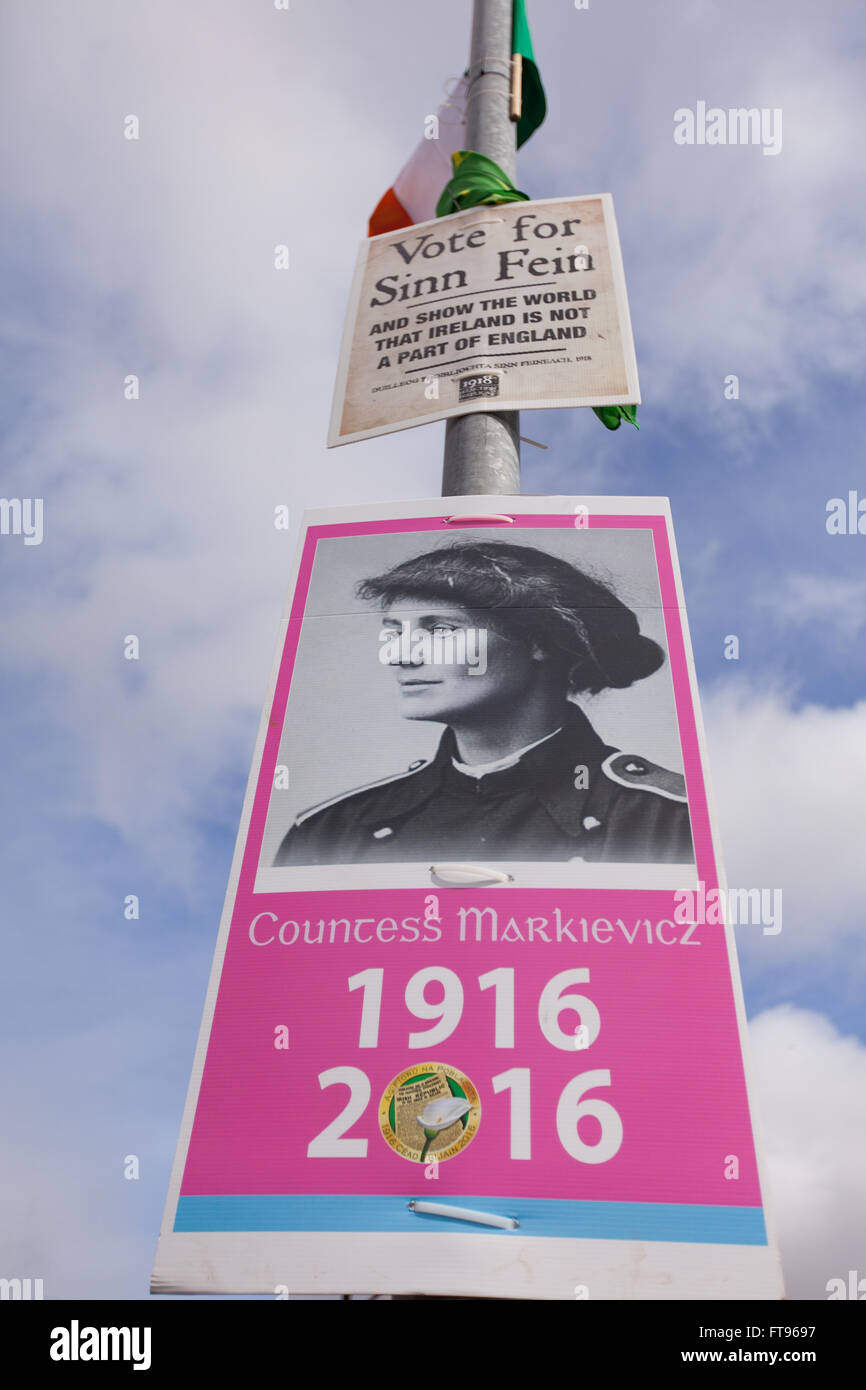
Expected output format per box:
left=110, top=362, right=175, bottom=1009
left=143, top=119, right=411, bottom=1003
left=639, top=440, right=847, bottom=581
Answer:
left=274, top=539, right=694, bottom=865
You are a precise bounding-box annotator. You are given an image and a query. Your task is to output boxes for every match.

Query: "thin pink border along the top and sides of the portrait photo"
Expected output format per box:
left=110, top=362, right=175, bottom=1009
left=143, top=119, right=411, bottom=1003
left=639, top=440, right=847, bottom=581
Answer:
left=238, top=513, right=719, bottom=897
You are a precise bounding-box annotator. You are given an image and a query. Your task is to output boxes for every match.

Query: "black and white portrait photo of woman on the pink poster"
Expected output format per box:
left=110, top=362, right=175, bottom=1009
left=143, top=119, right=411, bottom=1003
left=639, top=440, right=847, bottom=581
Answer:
left=255, top=517, right=694, bottom=869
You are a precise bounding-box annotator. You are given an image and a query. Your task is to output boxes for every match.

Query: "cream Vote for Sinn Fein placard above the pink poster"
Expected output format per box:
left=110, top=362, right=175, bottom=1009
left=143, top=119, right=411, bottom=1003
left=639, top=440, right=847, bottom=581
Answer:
left=328, top=193, right=641, bottom=446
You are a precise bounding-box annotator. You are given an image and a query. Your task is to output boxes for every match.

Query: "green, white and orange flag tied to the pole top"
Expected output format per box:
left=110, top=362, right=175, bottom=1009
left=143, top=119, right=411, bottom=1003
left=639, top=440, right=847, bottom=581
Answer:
left=370, top=0, right=546, bottom=236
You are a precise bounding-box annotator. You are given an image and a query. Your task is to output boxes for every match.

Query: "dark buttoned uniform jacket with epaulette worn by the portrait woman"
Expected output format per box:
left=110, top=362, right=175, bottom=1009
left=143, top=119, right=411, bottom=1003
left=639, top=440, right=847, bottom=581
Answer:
left=274, top=705, right=694, bottom=866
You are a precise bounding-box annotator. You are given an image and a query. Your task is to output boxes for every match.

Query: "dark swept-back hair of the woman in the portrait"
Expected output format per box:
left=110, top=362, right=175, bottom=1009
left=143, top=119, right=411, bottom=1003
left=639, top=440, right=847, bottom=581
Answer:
left=356, top=541, right=664, bottom=695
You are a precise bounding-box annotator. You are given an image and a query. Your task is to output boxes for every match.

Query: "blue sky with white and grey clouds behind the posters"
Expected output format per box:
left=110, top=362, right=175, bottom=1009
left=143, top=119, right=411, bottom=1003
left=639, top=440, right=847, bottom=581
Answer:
left=0, top=0, right=866, bottom=1298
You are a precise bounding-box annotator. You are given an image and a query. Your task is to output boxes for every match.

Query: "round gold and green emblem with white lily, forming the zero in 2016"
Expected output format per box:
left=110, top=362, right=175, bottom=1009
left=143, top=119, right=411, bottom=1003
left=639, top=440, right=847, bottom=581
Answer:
left=379, top=1062, right=481, bottom=1163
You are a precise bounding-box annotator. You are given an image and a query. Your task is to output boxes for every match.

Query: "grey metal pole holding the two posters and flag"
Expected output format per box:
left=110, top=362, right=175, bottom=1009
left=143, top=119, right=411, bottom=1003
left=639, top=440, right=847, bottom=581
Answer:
left=442, top=0, right=520, bottom=498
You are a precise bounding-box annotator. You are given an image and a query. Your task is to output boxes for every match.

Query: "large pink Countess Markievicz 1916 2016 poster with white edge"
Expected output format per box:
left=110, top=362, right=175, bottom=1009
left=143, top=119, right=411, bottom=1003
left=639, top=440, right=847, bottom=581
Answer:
left=153, top=498, right=781, bottom=1300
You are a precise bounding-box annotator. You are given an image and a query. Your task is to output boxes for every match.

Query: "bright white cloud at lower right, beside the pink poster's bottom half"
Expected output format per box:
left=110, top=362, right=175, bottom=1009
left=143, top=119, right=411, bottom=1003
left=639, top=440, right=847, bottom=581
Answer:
left=749, top=1005, right=866, bottom=1298
